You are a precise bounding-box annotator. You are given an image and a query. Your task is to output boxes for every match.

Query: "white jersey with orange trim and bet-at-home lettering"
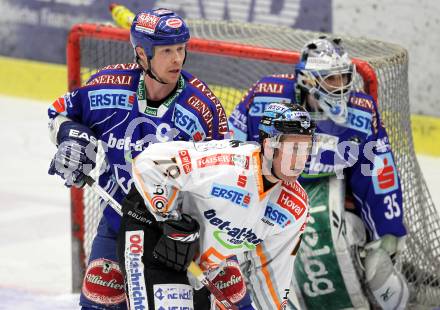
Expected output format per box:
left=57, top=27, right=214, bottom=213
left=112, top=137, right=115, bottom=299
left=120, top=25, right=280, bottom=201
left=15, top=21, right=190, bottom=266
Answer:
left=133, top=140, right=308, bottom=309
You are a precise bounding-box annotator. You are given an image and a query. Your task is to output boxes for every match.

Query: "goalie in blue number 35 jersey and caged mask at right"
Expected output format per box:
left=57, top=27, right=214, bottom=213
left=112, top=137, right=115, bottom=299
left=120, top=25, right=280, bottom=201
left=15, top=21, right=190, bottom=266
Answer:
left=229, top=37, right=408, bottom=309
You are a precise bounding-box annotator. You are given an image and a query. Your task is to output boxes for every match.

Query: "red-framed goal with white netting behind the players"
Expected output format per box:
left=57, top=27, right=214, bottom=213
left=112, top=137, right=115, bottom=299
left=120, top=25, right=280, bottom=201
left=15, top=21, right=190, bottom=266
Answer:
left=67, top=20, right=440, bottom=306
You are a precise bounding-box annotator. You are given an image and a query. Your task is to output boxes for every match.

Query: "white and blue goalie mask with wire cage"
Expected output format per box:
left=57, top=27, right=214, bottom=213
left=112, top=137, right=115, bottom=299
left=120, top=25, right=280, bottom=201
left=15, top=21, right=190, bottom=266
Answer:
left=295, top=37, right=356, bottom=123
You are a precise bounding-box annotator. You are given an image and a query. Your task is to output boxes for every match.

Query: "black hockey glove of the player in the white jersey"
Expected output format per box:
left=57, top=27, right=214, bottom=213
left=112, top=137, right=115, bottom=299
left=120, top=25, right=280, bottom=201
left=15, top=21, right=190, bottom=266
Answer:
left=153, top=214, right=200, bottom=271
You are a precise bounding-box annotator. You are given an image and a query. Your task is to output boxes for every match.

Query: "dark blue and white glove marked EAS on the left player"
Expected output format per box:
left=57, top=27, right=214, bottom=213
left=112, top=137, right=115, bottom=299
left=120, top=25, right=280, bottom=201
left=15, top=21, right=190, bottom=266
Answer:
left=49, top=121, right=98, bottom=187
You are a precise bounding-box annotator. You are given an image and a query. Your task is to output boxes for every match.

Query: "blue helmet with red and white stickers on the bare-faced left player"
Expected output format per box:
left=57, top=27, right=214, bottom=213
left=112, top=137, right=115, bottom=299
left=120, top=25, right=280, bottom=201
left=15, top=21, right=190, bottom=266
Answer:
left=130, top=8, right=190, bottom=59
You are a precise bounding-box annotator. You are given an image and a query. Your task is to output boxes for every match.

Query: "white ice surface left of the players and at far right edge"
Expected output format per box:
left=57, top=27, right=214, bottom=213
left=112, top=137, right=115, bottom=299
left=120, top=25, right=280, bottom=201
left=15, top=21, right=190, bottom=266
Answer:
left=0, top=96, right=440, bottom=310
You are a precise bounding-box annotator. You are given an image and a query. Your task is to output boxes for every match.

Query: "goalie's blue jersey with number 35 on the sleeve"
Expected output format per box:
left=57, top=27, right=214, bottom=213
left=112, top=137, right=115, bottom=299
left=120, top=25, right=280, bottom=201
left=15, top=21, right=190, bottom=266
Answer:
left=229, top=74, right=406, bottom=239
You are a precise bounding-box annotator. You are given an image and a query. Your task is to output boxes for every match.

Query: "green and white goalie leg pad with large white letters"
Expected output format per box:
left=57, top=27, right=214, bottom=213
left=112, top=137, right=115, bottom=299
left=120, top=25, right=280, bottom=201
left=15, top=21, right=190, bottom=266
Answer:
left=290, top=178, right=368, bottom=310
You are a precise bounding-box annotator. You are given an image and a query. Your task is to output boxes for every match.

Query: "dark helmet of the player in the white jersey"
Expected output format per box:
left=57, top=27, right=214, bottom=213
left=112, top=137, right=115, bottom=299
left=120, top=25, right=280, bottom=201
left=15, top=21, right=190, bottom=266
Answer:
left=258, top=102, right=316, bottom=144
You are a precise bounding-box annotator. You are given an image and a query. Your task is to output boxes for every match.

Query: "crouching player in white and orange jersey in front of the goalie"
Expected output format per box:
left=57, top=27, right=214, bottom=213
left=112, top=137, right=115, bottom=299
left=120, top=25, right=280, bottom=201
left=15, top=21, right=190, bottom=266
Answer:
left=118, top=103, right=315, bottom=309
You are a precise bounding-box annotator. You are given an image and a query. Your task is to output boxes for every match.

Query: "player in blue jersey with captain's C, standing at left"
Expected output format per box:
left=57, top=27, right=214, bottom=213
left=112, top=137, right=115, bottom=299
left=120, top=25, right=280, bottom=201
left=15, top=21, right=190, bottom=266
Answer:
left=49, top=9, right=228, bottom=309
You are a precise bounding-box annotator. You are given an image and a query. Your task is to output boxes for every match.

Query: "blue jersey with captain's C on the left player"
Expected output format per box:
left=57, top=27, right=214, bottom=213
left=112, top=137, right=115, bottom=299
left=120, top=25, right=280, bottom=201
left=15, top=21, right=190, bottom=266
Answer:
left=49, top=64, right=228, bottom=231
